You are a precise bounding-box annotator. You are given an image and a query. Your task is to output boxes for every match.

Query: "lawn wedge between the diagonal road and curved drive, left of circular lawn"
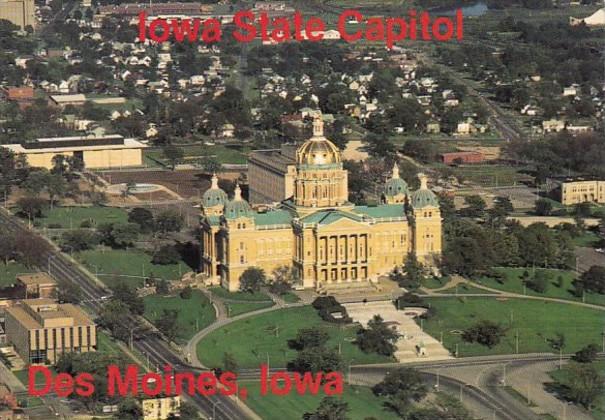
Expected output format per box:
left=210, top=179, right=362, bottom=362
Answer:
left=144, top=290, right=216, bottom=342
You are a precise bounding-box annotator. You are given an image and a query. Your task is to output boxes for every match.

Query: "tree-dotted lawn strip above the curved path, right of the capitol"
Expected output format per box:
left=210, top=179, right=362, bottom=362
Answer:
left=479, top=268, right=605, bottom=306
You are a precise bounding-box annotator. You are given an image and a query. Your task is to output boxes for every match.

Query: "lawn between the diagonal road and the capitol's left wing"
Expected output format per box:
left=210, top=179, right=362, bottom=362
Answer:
left=76, top=249, right=191, bottom=286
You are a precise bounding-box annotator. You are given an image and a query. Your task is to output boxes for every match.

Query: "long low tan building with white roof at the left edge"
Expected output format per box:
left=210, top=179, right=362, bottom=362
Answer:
left=2, top=134, right=147, bottom=169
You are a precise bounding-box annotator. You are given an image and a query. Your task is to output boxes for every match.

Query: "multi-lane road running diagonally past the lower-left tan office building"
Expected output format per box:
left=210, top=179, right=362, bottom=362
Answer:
left=0, top=209, right=253, bottom=420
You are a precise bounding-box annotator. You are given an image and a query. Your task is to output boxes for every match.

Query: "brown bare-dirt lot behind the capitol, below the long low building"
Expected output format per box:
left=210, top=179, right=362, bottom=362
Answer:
left=100, top=170, right=239, bottom=199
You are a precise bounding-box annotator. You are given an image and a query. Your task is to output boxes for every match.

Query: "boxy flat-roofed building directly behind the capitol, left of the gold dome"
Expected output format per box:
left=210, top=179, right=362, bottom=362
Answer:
left=248, top=145, right=297, bottom=204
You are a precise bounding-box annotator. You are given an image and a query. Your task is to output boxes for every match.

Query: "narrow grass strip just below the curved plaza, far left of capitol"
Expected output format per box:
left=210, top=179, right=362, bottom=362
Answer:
left=38, top=207, right=128, bottom=229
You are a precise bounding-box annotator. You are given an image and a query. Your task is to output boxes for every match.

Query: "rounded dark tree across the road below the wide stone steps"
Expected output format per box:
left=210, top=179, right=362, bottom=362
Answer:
left=372, top=368, right=428, bottom=418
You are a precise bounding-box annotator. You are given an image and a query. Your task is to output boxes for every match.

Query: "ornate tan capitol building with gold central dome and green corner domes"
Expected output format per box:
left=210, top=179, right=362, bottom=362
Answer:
left=201, top=118, right=442, bottom=291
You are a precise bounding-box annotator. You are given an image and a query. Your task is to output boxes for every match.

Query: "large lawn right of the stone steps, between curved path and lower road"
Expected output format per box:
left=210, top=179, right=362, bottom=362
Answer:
left=424, top=297, right=605, bottom=356
